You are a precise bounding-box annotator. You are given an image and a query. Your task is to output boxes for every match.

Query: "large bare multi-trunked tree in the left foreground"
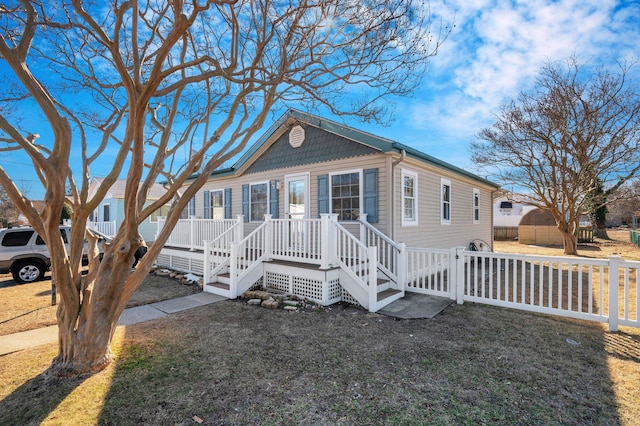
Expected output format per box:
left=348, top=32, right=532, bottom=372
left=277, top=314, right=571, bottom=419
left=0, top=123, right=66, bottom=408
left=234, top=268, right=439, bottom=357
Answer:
left=0, top=0, right=448, bottom=374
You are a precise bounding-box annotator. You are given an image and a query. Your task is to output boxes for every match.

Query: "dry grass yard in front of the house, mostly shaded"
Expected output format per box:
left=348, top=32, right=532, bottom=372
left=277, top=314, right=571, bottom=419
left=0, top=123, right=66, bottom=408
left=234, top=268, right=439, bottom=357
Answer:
left=0, top=233, right=640, bottom=425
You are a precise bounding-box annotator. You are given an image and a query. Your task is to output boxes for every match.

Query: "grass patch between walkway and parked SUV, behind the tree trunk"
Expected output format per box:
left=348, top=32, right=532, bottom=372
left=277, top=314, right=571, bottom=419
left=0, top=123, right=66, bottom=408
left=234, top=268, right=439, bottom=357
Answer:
left=0, top=274, right=201, bottom=336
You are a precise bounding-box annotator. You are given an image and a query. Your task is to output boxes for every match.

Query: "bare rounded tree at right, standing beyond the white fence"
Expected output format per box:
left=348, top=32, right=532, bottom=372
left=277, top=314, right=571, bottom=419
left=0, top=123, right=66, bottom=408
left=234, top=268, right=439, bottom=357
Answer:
left=471, top=58, right=640, bottom=254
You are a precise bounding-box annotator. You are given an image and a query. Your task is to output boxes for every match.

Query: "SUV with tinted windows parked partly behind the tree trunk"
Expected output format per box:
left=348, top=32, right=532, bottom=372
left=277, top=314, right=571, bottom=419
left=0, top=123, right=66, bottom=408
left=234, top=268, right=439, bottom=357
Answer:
left=0, top=226, right=108, bottom=283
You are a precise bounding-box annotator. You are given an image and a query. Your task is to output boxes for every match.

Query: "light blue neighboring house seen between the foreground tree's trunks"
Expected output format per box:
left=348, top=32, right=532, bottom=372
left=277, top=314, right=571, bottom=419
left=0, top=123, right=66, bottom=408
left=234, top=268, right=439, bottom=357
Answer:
left=89, top=178, right=169, bottom=242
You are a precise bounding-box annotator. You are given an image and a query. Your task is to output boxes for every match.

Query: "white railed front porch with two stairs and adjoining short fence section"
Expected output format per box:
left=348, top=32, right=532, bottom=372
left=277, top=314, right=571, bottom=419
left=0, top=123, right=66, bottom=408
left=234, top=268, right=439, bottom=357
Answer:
left=158, top=214, right=453, bottom=312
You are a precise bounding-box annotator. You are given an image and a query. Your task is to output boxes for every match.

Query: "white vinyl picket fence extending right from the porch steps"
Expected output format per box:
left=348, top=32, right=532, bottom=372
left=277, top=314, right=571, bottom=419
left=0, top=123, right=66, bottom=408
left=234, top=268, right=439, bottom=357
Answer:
left=428, top=248, right=640, bottom=331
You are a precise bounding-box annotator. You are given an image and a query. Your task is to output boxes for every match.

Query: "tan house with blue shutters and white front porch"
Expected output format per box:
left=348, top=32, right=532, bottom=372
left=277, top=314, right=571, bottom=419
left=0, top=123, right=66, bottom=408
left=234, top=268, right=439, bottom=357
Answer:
left=158, top=110, right=498, bottom=311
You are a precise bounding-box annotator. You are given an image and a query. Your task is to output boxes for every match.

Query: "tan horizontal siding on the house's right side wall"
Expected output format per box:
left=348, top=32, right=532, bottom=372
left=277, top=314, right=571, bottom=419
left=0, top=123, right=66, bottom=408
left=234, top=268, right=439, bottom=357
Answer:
left=394, top=161, right=493, bottom=248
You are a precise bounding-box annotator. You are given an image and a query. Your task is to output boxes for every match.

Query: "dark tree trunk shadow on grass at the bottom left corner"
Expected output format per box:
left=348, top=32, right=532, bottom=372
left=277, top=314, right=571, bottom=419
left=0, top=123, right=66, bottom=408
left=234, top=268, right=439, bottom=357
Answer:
left=0, top=369, right=90, bottom=425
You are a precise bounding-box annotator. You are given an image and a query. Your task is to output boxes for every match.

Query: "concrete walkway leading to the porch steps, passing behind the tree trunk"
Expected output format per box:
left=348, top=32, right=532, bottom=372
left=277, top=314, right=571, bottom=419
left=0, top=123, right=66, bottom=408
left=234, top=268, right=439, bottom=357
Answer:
left=0, top=293, right=226, bottom=356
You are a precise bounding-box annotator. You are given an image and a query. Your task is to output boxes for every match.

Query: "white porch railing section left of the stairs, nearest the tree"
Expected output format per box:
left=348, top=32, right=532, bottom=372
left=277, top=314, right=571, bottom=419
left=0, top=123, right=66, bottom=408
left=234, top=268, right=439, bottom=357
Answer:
left=156, top=218, right=238, bottom=250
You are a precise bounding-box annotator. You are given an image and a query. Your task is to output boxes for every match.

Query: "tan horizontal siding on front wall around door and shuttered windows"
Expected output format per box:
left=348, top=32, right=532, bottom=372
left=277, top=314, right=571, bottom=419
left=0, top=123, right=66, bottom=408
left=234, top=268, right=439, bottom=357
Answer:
left=196, top=154, right=388, bottom=240
